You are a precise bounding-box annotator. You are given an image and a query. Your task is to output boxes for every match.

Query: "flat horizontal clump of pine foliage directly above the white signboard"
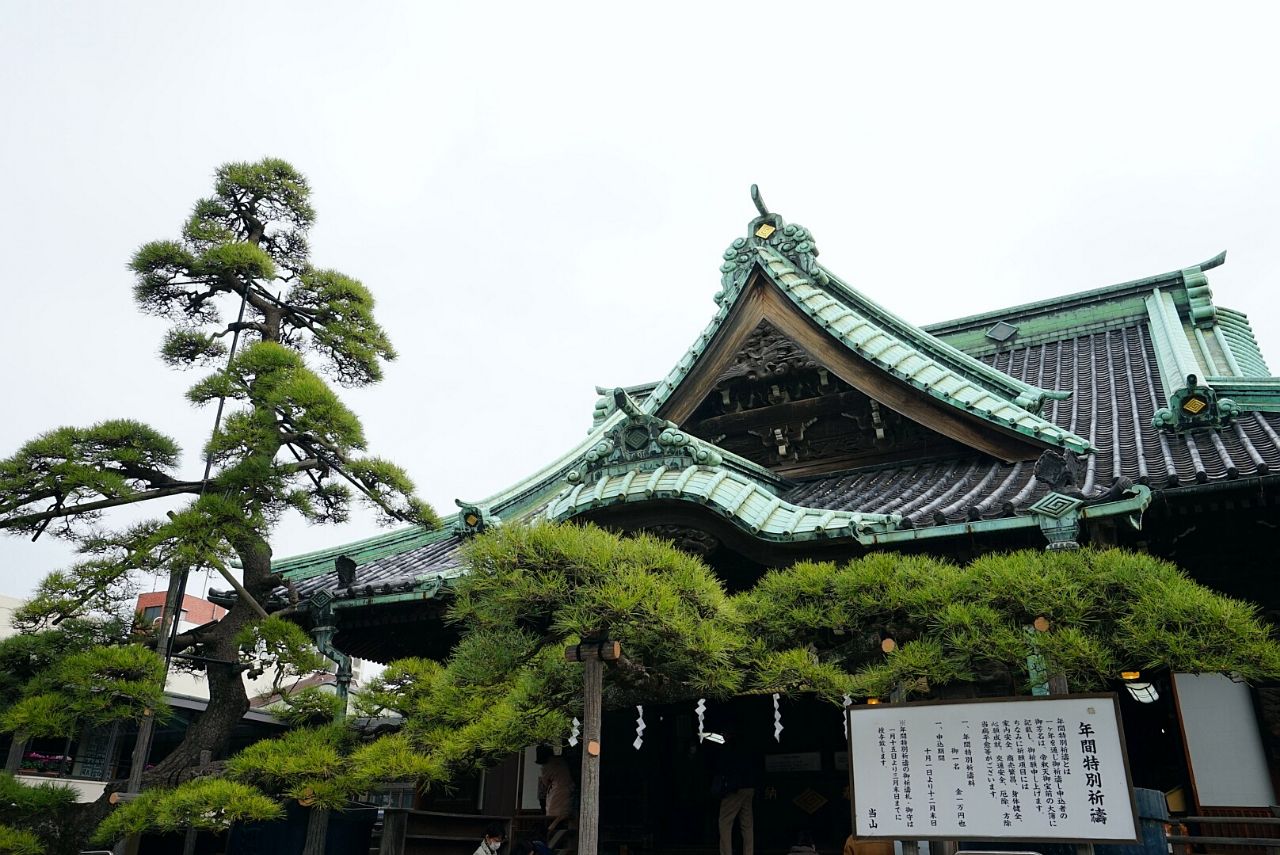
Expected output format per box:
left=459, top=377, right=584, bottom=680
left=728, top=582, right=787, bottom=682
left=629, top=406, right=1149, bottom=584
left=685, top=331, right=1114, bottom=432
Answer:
left=735, top=549, right=1280, bottom=696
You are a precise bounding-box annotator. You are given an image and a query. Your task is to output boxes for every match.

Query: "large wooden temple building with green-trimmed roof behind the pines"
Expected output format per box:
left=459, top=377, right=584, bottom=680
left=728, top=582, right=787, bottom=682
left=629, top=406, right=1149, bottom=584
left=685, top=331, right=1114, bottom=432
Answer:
left=270, top=188, right=1280, bottom=851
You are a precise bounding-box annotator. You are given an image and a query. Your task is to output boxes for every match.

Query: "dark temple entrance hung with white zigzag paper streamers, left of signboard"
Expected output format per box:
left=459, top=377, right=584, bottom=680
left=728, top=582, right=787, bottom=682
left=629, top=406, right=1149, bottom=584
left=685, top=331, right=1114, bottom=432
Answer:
left=600, top=695, right=849, bottom=855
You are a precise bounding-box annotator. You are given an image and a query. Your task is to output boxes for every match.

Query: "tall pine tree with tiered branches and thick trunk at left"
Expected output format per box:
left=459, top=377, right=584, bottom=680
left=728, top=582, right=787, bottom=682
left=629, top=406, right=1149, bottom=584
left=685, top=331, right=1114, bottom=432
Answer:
left=0, top=159, right=438, bottom=785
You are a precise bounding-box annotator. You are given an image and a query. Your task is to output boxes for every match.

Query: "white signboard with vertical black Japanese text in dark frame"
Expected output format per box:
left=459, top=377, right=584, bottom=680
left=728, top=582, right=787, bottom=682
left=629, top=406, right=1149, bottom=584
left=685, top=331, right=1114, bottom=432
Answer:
left=847, top=695, right=1138, bottom=842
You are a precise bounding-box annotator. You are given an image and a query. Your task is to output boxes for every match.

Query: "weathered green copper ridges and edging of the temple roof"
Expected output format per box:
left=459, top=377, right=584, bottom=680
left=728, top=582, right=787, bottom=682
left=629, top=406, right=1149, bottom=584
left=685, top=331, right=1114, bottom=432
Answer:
left=274, top=190, right=1280, bottom=583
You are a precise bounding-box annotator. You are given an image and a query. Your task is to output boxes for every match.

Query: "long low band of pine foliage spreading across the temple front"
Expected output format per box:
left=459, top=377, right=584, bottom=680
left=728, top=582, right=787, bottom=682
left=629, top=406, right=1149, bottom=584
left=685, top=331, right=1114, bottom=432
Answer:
left=92, top=535, right=1280, bottom=836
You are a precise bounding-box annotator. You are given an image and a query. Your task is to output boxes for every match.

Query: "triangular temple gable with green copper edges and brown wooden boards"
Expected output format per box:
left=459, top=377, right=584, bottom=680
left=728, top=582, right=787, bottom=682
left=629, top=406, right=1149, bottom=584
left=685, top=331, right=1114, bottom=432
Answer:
left=646, top=204, right=1091, bottom=463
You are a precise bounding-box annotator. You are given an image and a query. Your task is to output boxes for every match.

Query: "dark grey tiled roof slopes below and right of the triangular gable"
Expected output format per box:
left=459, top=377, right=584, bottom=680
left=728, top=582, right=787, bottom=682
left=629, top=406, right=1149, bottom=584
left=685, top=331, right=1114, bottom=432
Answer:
left=785, top=323, right=1280, bottom=526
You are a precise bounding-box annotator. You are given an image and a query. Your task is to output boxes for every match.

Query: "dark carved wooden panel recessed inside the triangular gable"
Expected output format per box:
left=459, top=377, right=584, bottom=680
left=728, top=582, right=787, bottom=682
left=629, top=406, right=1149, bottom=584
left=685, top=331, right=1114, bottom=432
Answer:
left=685, top=320, right=956, bottom=475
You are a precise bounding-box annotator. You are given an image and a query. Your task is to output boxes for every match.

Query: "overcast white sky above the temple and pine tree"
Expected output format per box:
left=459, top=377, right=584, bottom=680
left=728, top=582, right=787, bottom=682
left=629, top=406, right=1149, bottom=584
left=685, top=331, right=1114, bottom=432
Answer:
left=0, top=0, right=1280, bottom=595
